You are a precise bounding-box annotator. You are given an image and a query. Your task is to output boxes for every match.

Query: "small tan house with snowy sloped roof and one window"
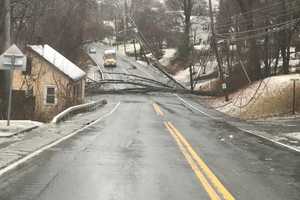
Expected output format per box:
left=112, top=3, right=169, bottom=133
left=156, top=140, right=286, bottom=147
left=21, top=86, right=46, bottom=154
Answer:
left=13, top=45, right=86, bottom=121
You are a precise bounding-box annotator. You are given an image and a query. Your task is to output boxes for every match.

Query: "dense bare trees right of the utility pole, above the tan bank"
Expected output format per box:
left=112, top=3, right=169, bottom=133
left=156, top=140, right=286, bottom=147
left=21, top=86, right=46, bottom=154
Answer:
left=216, top=0, right=300, bottom=86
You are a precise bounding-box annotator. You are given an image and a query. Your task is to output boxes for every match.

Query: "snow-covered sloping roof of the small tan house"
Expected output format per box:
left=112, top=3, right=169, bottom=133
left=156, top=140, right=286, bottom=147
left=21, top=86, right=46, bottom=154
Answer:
left=28, top=44, right=86, bottom=81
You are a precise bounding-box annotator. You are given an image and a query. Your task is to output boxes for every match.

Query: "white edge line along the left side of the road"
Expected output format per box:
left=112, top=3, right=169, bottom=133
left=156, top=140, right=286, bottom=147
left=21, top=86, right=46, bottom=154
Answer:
left=0, top=102, right=121, bottom=177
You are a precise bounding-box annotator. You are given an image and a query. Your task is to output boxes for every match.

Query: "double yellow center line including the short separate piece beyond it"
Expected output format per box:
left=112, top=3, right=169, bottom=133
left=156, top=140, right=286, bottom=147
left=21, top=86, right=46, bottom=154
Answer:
left=153, top=104, right=235, bottom=200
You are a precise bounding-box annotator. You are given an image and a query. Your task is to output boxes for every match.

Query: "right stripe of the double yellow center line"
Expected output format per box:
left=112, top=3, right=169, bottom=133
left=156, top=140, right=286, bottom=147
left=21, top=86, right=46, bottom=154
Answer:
left=167, top=122, right=235, bottom=200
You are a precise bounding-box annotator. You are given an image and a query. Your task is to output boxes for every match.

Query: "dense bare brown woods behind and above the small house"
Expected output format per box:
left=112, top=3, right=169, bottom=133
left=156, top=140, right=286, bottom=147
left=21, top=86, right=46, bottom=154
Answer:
left=0, top=0, right=109, bottom=60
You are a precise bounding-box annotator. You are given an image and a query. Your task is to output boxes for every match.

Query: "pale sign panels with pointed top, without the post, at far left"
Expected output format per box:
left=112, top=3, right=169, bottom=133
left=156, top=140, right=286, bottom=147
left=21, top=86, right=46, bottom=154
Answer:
left=0, top=45, right=27, bottom=71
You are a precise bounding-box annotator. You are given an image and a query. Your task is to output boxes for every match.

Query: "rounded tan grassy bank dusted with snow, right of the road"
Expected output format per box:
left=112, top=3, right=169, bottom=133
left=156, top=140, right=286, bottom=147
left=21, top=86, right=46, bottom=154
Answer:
left=205, top=74, right=300, bottom=119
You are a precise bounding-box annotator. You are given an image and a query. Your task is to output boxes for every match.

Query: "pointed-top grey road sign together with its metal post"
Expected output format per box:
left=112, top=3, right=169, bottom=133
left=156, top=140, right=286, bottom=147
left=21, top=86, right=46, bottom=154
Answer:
left=0, top=45, right=27, bottom=126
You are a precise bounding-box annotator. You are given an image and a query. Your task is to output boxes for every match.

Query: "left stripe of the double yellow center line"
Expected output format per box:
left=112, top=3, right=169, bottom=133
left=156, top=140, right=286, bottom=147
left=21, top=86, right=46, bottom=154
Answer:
left=164, top=122, right=220, bottom=200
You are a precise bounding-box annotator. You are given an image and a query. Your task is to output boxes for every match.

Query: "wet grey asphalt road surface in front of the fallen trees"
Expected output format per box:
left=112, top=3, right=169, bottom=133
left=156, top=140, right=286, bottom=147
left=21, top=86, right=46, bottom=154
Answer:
left=0, top=44, right=300, bottom=200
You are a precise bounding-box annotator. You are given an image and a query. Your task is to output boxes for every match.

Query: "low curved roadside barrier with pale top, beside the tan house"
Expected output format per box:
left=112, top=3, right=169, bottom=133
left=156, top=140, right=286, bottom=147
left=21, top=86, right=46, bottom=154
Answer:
left=51, top=100, right=107, bottom=124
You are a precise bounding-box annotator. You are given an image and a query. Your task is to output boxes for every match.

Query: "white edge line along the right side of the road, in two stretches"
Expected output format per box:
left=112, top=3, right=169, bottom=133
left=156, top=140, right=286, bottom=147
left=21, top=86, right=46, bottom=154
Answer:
left=174, top=94, right=300, bottom=153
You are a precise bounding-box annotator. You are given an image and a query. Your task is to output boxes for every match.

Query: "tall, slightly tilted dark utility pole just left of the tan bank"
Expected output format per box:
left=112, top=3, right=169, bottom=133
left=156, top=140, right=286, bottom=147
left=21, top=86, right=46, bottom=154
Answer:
left=209, top=0, right=228, bottom=101
